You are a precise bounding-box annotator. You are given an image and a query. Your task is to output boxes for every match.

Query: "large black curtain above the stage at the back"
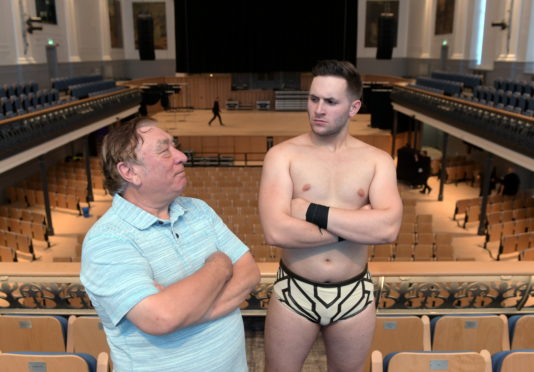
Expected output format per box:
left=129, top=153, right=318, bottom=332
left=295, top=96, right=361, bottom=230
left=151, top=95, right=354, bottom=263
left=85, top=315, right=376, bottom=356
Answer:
left=175, top=0, right=358, bottom=73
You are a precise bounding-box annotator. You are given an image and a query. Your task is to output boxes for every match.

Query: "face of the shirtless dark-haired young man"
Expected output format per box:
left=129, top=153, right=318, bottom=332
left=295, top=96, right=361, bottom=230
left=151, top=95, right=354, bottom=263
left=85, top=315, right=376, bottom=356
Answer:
left=308, top=76, right=361, bottom=136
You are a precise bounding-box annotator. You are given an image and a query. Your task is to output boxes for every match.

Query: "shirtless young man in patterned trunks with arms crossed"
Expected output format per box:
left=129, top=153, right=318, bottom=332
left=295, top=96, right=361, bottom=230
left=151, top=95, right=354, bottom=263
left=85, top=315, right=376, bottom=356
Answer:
left=259, top=61, right=402, bottom=372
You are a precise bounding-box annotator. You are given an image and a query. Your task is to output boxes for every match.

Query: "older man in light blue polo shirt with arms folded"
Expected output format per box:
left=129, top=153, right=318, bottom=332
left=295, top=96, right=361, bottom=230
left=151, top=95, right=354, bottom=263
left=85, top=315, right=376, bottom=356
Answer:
left=80, top=118, right=259, bottom=372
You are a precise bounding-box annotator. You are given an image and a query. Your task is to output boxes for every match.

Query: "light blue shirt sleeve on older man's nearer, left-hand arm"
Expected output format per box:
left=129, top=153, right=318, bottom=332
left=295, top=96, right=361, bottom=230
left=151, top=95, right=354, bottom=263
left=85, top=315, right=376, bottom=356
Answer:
left=80, top=233, right=158, bottom=326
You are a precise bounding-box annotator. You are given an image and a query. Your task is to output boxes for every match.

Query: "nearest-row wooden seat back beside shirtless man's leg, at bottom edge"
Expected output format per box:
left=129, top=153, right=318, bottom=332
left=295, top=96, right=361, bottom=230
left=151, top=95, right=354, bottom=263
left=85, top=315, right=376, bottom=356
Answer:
left=373, top=350, right=491, bottom=372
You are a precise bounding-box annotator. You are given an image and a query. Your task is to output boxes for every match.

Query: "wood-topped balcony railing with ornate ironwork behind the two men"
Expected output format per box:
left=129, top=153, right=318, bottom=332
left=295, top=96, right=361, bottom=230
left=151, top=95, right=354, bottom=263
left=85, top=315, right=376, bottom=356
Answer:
left=0, top=261, right=534, bottom=315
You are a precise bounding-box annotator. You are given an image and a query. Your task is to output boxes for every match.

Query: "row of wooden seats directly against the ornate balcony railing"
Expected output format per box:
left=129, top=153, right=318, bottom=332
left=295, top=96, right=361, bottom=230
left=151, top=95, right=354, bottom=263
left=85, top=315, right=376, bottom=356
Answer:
left=0, top=314, right=534, bottom=370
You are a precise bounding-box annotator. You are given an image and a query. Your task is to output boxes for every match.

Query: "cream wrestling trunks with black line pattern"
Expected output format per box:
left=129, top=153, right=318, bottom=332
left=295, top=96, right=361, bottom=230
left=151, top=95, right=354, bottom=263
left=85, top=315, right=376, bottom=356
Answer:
left=273, top=261, right=374, bottom=326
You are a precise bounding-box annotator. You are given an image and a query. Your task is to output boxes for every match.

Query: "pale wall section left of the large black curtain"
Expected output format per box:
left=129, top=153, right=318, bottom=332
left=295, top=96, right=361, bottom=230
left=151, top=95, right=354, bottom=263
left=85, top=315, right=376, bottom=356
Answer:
left=0, top=0, right=175, bottom=66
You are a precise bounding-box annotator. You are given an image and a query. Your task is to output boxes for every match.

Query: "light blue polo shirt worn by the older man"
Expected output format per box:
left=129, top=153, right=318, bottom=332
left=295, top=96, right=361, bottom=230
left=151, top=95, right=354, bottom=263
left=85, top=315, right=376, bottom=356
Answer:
left=80, top=195, right=248, bottom=372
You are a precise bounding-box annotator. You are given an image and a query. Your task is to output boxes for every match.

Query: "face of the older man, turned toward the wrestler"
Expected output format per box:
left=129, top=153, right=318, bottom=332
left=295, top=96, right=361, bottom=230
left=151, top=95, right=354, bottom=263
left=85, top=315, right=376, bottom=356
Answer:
left=136, top=126, right=187, bottom=198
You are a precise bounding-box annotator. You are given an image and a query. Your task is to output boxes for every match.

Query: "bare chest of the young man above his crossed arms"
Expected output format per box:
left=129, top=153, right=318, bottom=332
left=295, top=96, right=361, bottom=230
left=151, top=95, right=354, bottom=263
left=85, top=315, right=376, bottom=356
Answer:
left=290, top=148, right=375, bottom=209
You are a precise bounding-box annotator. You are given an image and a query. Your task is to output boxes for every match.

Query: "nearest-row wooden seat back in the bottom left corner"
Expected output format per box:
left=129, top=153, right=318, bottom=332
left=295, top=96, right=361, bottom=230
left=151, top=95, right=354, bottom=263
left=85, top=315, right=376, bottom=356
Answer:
left=0, top=352, right=98, bottom=372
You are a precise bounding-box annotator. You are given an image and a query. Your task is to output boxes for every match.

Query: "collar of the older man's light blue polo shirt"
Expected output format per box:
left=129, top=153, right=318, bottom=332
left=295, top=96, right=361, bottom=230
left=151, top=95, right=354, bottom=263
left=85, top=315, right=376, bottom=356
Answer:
left=112, top=194, right=187, bottom=230
